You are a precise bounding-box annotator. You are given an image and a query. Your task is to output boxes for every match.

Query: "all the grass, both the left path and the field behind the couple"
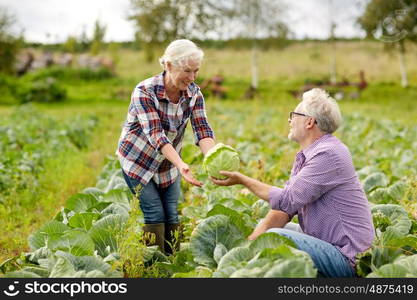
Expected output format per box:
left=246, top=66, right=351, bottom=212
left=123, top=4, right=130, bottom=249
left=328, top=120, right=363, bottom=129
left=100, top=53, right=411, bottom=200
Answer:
left=0, top=42, right=417, bottom=261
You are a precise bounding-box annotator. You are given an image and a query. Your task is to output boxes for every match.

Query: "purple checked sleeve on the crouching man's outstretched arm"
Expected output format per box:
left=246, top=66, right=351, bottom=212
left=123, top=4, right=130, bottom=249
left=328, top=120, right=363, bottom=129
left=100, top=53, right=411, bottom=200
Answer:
left=269, top=152, right=340, bottom=216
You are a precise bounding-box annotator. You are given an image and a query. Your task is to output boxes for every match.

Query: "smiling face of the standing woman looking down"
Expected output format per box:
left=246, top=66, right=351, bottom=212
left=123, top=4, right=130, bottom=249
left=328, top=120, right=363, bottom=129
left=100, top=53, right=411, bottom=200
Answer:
left=167, top=59, right=201, bottom=91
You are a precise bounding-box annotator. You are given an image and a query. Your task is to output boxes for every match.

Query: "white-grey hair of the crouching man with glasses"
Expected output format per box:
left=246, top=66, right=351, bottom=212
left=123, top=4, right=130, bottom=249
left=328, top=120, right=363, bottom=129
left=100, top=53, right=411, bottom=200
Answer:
left=301, top=88, right=342, bottom=133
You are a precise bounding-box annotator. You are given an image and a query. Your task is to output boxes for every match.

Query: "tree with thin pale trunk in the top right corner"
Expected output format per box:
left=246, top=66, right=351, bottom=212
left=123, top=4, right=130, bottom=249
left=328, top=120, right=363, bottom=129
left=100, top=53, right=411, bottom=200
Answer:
left=358, top=0, right=417, bottom=87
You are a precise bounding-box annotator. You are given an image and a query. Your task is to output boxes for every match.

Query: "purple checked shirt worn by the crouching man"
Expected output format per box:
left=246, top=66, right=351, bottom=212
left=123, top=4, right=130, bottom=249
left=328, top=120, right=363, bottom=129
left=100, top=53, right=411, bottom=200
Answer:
left=269, top=134, right=375, bottom=266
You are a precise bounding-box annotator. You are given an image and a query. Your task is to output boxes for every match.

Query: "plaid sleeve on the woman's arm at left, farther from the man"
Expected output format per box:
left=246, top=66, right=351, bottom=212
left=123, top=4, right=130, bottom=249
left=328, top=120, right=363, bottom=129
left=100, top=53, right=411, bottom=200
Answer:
left=131, top=88, right=170, bottom=151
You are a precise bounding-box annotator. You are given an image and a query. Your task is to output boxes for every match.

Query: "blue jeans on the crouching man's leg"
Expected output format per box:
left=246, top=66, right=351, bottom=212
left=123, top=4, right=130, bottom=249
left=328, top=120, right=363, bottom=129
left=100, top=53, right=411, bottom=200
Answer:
left=268, top=228, right=355, bottom=277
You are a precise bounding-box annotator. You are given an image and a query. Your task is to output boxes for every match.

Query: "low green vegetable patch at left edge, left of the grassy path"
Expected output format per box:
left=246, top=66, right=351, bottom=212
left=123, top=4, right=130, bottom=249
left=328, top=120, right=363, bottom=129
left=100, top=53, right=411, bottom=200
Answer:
left=0, top=105, right=98, bottom=203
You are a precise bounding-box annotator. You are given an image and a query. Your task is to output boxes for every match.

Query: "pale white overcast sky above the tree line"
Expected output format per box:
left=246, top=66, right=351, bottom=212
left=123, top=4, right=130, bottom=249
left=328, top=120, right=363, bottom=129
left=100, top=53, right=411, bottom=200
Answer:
left=0, top=0, right=367, bottom=43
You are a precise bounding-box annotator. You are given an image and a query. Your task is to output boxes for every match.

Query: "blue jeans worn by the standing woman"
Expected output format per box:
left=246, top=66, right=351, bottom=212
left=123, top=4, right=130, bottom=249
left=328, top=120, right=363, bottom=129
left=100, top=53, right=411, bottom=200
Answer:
left=123, top=172, right=181, bottom=224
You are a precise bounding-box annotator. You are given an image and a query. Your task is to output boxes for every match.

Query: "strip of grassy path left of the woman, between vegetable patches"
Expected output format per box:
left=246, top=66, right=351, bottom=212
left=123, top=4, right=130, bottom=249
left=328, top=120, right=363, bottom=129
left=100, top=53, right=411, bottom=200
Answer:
left=0, top=103, right=126, bottom=261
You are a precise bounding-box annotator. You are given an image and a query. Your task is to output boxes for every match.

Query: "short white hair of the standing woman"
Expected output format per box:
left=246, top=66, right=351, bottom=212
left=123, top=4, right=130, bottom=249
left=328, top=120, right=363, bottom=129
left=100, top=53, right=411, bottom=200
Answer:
left=159, top=39, right=204, bottom=69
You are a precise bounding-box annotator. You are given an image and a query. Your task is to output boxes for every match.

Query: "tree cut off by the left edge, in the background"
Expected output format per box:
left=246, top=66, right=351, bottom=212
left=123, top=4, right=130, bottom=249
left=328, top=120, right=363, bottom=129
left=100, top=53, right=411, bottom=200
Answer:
left=0, top=8, right=22, bottom=74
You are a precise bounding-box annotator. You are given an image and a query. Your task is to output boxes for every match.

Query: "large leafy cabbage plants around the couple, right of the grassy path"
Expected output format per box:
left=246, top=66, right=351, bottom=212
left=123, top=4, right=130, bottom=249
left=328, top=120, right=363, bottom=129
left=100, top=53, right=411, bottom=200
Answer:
left=0, top=111, right=417, bottom=278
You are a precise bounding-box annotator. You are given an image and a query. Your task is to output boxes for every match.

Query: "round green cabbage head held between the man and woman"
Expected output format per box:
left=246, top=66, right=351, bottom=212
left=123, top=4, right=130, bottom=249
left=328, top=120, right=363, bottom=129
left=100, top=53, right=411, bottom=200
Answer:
left=203, top=143, right=240, bottom=179
